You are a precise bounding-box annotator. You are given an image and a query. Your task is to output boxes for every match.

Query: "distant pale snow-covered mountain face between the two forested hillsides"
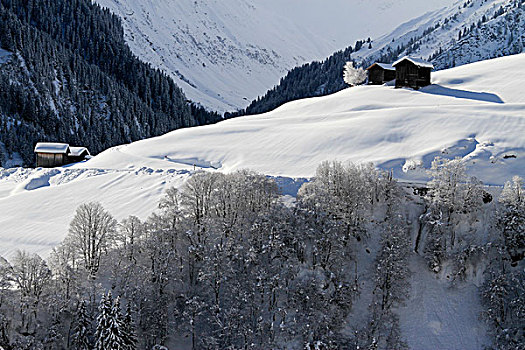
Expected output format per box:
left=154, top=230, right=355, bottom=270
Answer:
left=96, top=0, right=454, bottom=111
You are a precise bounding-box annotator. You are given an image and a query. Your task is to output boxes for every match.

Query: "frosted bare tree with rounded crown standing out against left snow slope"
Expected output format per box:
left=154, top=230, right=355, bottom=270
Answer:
left=68, top=202, right=117, bottom=276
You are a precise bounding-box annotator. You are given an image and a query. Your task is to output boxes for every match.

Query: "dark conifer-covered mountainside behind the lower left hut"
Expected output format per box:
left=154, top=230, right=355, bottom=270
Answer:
left=0, top=0, right=220, bottom=165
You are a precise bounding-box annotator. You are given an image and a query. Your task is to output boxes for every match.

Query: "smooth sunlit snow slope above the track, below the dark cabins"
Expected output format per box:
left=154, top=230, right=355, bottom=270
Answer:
left=82, top=54, right=525, bottom=184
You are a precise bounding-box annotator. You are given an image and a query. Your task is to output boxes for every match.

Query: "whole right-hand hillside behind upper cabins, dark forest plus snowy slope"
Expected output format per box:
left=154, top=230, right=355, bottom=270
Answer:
left=239, top=0, right=525, bottom=114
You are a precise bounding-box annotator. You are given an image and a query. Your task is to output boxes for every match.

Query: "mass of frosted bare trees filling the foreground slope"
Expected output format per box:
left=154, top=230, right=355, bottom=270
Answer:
left=0, top=159, right=525, bottom=350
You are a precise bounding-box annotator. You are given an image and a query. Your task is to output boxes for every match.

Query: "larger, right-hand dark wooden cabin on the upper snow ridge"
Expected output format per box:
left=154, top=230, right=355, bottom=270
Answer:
left=392, top=56, right=434, bottom=90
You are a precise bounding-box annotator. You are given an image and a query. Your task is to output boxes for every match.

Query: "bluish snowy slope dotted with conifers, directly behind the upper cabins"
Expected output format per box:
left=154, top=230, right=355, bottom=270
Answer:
left=352, top=0, right=525, bottom=69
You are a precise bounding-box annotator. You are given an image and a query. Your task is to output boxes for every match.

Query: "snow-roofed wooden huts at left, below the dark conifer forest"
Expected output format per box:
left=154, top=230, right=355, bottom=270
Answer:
left=35, top=142, right=90, bottom=168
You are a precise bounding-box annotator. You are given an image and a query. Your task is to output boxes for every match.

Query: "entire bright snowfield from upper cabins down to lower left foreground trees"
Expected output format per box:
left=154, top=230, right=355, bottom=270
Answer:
left=0, top=54, right=525, bottom=256
